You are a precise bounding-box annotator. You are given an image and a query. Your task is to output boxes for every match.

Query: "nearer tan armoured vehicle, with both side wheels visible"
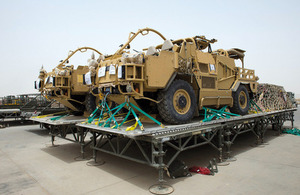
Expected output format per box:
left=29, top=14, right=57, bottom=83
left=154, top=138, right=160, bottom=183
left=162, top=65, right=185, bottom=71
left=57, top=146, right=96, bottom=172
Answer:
left=98, top=28, right=258, bottom=124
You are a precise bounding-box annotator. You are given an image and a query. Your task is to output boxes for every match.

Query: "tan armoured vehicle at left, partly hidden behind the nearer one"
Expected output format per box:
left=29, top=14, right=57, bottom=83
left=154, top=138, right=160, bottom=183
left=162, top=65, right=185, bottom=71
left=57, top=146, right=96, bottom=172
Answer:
left=35, top=47, right=104, bottom=115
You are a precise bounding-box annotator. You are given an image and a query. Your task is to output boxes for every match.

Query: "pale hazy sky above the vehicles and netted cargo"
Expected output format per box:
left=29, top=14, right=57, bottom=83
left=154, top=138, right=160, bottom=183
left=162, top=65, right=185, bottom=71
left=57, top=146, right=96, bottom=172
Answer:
left=0, top=0, right=300, bottom=96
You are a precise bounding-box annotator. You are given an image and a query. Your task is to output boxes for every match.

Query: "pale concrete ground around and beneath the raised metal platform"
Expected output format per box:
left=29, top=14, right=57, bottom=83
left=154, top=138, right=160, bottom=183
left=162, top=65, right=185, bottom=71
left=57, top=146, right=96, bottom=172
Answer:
left=0, top=110, right=300, bottom=195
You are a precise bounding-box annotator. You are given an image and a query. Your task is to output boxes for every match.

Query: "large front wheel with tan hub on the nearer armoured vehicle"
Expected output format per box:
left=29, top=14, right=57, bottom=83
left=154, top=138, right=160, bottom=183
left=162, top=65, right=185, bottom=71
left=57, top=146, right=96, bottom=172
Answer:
left=158, top=80, right=197, bottom=124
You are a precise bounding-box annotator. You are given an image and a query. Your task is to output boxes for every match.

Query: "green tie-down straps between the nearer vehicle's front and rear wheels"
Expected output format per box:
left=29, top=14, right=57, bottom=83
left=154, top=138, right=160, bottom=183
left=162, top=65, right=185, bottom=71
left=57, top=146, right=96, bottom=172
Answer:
left=202, top=106, right=240, bottom=122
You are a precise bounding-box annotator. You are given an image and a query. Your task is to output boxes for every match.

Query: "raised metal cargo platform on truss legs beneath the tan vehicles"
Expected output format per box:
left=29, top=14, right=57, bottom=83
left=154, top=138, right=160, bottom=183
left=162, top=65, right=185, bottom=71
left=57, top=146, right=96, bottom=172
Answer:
left=29, top=108, right=297, bottom=191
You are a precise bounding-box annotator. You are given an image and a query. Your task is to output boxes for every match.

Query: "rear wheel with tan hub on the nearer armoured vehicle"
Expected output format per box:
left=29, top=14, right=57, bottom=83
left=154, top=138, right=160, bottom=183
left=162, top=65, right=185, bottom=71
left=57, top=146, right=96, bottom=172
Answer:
left=230, top=85, right=250, bottom=115
